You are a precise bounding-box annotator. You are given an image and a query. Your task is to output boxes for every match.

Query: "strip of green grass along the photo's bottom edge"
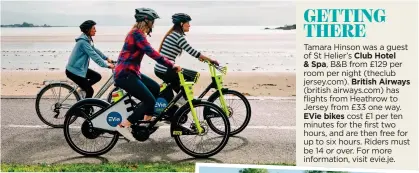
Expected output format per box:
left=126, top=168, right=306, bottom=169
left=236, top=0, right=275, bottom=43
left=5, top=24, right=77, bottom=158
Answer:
left=1, top=162, right=295, bottom=172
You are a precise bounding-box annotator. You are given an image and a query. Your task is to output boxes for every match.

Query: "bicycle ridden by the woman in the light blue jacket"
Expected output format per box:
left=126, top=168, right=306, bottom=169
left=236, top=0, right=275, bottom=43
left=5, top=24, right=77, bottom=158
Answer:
left=35, top=61, right=116, bottom=128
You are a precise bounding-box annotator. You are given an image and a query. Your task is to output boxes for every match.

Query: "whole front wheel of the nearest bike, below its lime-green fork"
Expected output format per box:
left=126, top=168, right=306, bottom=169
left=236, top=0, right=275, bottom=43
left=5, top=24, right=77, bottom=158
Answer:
left=171, top=100, right=230, bottom=158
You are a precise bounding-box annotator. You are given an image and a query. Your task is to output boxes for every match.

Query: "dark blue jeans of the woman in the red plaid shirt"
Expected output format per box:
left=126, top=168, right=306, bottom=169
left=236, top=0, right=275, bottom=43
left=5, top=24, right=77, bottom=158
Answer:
left=115, top=74, right=160, bottom=124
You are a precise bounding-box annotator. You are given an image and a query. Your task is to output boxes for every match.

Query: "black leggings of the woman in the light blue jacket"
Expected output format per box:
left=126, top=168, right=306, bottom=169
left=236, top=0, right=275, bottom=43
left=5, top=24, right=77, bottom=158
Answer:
left=65, top=69, right=102, bottom=98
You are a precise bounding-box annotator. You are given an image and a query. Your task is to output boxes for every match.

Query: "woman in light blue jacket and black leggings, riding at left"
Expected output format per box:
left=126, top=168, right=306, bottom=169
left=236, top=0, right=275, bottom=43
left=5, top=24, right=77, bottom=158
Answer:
left=65, top=20, right=115, bottom=98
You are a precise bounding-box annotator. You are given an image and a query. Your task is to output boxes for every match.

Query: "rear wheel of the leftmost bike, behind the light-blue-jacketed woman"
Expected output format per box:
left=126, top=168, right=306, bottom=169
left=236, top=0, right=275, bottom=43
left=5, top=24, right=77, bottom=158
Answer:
left=35, top=83, right=81, bottom=128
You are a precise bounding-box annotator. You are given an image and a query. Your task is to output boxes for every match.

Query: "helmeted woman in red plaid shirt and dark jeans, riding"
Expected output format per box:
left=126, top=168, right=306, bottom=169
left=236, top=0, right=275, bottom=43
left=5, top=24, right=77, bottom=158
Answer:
left=114, top=8, right=180, bottom=141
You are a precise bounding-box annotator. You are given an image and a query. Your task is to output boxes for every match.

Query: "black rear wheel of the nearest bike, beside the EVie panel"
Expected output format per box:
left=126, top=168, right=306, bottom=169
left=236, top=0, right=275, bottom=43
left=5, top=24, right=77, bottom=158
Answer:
left=64, top=99, right=119, bottom=156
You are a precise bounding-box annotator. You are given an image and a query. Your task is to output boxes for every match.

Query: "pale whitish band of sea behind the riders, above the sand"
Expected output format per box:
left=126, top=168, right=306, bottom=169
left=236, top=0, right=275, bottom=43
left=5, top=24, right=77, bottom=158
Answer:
left=1, top=26, right=295, bottom=72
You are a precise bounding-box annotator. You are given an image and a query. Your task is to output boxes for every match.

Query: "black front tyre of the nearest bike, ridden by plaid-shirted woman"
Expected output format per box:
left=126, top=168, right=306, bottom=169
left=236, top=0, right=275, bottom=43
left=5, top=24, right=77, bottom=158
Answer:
left=172, top=100, right=230, bottom=158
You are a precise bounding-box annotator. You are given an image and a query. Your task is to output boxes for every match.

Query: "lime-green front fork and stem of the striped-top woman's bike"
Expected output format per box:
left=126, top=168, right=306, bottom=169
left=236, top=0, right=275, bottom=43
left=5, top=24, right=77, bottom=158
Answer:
left=198, top=61, right=230, bottom=117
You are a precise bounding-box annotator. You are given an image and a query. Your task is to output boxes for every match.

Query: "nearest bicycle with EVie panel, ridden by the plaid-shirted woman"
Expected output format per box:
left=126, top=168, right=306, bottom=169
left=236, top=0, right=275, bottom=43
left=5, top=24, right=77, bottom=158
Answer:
left=64, top=67, right=230, bottom=158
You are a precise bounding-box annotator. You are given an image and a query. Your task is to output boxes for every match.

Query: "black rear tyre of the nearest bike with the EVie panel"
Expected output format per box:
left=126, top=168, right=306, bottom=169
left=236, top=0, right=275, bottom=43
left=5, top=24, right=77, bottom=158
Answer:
left=64, top=98, right=119, bottom=156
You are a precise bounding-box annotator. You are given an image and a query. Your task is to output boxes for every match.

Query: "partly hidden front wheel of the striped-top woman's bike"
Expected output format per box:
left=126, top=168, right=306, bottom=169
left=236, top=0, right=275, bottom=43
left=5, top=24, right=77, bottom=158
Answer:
left=208, top=90, right=252, bottom=136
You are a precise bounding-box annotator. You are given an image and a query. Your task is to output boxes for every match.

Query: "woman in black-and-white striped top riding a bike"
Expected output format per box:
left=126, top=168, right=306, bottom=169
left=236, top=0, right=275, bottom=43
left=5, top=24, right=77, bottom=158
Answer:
left=154, top=13, right=218, bottom=105
